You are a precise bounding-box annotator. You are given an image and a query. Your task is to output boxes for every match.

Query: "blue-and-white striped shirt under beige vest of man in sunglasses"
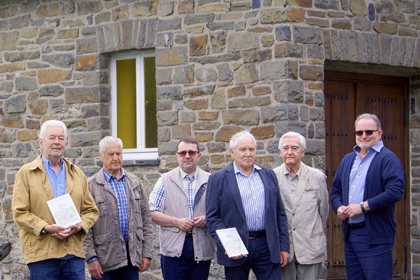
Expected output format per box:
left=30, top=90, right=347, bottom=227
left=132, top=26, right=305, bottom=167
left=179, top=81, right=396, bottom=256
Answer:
left=149, top=169, right=197, bottom=219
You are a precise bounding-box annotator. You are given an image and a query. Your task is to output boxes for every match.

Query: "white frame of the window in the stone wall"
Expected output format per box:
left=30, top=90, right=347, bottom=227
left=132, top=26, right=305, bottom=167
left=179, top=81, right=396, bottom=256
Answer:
left=111, top=50, right=159, bottom=160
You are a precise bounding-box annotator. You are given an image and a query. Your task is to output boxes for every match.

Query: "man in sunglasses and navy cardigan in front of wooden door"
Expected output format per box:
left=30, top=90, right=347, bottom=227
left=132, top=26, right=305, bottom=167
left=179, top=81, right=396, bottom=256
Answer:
left=330, top=113, right=404, bottom=280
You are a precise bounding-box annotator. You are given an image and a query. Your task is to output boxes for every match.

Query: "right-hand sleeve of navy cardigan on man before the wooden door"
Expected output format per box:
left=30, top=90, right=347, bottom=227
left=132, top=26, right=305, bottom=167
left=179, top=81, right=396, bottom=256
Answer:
left=368, top=154, right=404, bottom=210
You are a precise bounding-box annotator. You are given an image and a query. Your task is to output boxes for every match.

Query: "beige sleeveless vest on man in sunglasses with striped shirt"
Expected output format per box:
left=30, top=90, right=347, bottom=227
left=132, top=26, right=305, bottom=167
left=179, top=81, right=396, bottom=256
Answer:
left=155, top=167, right=215, bottom=261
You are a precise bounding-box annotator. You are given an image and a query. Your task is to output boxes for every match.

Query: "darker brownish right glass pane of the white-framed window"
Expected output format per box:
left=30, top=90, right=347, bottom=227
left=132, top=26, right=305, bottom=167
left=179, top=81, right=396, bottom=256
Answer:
left=144, top=57, right=157, bottom=148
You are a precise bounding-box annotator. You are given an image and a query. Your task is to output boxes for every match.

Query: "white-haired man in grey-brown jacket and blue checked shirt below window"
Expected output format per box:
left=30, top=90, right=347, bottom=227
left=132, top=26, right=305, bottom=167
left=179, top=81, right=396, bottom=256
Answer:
left=85, top=136, right=153, bottom=280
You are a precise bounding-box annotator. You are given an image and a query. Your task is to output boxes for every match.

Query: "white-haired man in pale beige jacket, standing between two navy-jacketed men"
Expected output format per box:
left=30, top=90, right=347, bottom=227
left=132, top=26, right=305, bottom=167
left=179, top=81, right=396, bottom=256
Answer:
left=274, top=132, right=328, bottom=280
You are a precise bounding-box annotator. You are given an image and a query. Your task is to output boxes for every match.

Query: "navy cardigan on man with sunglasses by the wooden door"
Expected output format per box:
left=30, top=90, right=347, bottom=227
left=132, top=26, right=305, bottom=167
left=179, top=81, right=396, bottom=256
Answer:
left=330, top=147, right=404, bottom=244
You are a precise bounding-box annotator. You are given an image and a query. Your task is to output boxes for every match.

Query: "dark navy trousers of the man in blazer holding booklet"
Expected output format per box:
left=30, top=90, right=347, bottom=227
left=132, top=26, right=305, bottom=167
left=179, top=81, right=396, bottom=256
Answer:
left=225, top=236, right=281, bottom=280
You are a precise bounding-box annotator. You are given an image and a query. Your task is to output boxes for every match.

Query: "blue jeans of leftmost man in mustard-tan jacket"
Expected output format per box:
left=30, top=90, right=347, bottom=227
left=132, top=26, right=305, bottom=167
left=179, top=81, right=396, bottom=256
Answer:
left=28, top=255, right=85, bottom=280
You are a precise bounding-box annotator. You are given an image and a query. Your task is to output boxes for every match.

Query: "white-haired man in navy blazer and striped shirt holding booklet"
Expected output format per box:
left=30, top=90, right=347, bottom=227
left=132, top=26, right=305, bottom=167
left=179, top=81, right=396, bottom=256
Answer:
left=206, top=131, right=289, bottom=280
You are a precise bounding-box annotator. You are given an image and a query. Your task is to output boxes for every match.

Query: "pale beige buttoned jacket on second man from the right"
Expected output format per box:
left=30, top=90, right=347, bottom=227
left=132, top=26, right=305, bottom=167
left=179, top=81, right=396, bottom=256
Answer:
left=273, top=162, right=329, bottom=264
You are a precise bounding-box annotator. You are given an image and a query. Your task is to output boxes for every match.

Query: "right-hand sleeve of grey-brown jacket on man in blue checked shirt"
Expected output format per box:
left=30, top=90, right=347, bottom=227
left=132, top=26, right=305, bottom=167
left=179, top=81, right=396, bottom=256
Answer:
left=139, top=185, right=154, bottom=259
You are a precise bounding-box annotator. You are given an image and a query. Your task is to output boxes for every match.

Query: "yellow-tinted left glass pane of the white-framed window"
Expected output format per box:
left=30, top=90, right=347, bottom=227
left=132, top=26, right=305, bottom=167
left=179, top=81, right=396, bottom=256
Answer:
left=117, top=59, right=137, bottom=149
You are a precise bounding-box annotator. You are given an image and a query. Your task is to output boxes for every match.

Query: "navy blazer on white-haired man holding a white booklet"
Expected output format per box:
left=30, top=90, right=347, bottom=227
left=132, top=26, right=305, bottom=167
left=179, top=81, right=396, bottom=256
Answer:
left=206, top=163, right=289, bottom=266
